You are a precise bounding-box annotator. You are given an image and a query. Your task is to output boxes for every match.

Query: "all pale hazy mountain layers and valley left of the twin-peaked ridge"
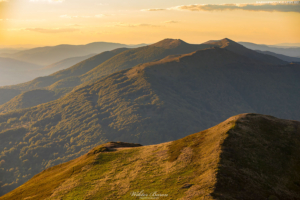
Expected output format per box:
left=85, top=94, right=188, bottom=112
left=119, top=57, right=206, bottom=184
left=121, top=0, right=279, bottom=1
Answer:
left=0, top=42, right=144, bottom=86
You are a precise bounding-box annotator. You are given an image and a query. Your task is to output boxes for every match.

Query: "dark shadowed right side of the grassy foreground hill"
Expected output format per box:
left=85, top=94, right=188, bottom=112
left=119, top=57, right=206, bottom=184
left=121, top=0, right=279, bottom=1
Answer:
left=212, top=114, right=300, bottom=200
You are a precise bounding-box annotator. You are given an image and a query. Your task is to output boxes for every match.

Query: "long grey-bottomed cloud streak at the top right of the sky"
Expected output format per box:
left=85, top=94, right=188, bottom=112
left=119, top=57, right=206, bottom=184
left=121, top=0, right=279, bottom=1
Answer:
left=142, top=1, right=300, bottom=13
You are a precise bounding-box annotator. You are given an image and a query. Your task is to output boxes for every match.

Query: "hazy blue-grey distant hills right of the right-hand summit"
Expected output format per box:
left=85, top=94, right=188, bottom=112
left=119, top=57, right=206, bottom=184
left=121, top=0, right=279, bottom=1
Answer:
left=239, top=42, right=300, bottom=57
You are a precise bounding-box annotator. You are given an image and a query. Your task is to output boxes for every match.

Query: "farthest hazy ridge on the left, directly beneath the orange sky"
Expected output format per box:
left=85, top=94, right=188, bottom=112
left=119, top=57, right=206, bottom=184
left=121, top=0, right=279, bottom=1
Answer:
left=1, top=42, right=145, bottom=66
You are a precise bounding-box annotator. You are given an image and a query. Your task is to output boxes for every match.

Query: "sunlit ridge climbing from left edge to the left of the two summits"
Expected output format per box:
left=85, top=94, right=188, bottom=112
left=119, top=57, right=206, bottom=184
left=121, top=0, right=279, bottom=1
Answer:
left=0, top=39, right=210, bottom=111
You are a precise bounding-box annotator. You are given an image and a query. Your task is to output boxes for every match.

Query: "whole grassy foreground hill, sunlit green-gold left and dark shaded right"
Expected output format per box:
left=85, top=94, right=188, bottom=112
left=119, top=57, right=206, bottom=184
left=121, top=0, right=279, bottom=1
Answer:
left=0, top=114, right=300, bottom=200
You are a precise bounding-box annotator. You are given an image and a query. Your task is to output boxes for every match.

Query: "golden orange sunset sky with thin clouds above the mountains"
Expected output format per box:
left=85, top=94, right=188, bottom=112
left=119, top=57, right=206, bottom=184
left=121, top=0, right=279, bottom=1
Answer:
left=0, top=0, right=300, bottom=47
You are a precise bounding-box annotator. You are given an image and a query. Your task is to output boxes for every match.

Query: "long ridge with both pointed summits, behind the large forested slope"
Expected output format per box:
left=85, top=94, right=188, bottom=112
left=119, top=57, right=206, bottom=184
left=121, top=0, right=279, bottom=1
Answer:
left=0, top=39, right=287, bottom=111
